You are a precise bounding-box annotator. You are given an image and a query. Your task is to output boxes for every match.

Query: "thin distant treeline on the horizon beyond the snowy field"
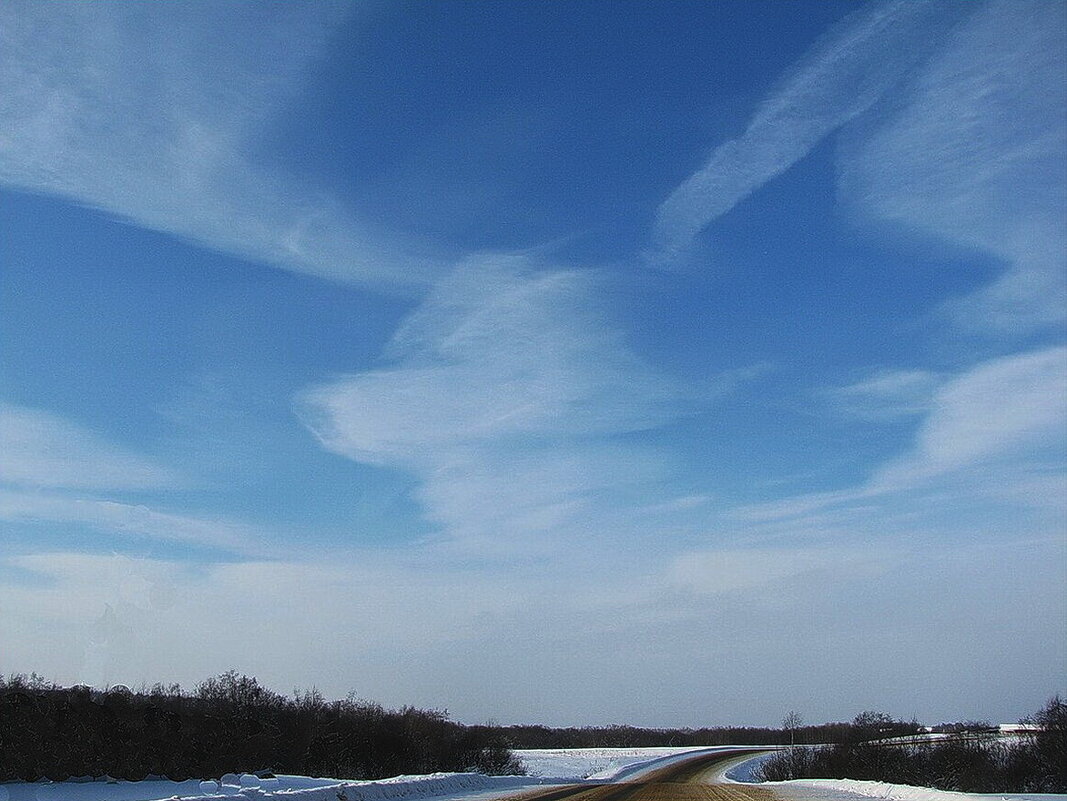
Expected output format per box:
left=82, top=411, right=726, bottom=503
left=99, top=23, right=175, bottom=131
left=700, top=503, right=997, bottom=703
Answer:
left=498, top=712, right=922, bottom=749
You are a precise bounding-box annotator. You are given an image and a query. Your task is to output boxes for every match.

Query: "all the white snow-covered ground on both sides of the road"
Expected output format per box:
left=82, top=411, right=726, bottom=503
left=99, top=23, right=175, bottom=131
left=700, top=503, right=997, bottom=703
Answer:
left=0, top=748, right=1067, bottom=801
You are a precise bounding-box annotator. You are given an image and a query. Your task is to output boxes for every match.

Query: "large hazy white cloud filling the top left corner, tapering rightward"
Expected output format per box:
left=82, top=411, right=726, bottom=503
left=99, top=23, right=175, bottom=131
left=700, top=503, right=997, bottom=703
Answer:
left=0, top=2, right=430, bottom=289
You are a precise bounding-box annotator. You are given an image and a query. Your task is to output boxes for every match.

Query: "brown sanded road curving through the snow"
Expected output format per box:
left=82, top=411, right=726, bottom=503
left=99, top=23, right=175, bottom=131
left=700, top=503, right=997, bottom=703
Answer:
left=495, top=749, right=778, bottom=801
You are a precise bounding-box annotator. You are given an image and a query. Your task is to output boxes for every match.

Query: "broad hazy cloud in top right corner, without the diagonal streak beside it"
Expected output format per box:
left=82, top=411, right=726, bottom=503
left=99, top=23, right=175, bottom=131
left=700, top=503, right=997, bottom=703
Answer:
left=841, top=2, right=1067, bottom=333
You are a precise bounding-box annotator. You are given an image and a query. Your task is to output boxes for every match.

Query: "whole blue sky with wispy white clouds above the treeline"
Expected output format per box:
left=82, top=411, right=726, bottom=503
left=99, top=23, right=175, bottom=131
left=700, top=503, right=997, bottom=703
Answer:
left=0, top=0, right=1067, bottom=726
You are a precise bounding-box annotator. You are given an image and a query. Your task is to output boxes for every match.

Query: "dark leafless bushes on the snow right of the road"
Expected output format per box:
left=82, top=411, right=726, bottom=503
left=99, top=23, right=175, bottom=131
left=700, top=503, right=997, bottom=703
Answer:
left=761, top=696, right=1067, bottom=792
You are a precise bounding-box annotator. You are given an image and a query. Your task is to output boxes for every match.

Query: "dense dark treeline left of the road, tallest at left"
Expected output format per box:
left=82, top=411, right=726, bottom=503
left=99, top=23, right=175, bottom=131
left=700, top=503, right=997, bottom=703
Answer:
left=0, top=671, right=522, bottom=781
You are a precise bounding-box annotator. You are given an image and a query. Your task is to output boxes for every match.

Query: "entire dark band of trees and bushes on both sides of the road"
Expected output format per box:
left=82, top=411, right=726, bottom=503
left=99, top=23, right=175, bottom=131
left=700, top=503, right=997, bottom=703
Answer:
left=0, top=671, right=1067, bottom=792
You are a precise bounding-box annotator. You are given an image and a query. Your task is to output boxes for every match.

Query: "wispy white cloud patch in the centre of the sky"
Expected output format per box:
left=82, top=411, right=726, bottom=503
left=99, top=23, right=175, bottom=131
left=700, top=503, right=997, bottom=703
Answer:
left=299, top=256, right=676, bottom=547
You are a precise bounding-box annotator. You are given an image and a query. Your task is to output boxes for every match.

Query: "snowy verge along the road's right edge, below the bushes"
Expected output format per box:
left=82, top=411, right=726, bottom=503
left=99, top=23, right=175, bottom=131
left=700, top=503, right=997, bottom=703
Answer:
left=719, top=754, right=1067, bottom=801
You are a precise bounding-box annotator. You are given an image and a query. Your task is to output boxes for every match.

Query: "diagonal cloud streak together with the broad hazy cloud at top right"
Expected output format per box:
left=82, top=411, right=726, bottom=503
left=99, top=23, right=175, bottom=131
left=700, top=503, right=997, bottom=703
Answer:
left=651, top=2, right=1067, bottom=336
